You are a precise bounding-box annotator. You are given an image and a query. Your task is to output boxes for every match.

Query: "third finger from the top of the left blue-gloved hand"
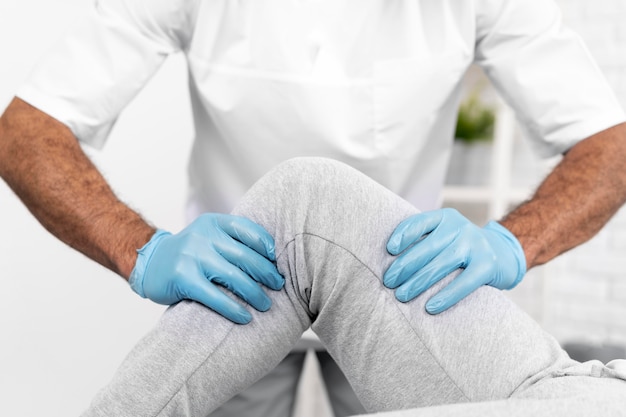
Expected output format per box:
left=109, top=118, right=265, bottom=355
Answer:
left=205, top=256, right=272, bottom=311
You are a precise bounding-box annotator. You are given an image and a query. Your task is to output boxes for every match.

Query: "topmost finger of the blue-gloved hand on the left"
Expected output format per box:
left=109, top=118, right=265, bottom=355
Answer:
left=218, top=215, right=276, bottom=261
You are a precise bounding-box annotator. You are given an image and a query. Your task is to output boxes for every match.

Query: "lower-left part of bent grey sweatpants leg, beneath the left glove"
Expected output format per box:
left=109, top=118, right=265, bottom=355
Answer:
left=83, top=291, right=310, bottom=417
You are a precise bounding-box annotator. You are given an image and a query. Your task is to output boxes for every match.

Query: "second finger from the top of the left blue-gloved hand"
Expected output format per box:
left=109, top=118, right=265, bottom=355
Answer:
left=215, top=240, right=285, bottom=290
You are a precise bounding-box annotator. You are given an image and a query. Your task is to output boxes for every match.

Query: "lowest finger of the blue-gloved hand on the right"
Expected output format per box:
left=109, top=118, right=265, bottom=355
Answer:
left=426, top=267, right=487, bottom=314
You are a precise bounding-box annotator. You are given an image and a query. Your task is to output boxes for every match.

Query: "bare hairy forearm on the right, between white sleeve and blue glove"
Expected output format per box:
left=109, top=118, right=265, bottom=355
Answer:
left=501, top=124, right=626, bottom=268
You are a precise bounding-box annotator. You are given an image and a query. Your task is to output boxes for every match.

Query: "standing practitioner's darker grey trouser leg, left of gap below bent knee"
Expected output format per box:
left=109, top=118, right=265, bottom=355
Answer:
left=209, top=352, right=306, bottom=417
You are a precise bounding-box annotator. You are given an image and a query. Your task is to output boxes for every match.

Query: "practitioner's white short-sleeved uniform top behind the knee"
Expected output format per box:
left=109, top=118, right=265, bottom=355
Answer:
left=18, top=0, right=625, bottom=414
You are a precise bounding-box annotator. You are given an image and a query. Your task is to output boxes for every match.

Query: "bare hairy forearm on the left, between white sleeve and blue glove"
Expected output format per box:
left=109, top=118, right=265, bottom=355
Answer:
left=0, top=98, right=154, bottom=279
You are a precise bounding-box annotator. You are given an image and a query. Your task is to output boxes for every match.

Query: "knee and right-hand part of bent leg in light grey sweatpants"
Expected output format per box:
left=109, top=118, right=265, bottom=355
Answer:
left=229, top=160, right=626, bottom=413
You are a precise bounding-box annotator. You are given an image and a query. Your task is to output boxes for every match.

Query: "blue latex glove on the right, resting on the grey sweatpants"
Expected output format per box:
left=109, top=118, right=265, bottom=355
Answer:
left=383, top=208, right=526, bottom=314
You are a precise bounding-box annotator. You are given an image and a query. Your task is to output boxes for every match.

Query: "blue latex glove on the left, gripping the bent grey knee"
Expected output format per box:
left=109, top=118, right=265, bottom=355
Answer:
left=129, top=213, right=285, bottom=324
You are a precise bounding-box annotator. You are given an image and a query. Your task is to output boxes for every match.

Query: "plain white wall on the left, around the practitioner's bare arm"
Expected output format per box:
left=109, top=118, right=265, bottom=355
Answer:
left=0, top=0, right=193, bottom=417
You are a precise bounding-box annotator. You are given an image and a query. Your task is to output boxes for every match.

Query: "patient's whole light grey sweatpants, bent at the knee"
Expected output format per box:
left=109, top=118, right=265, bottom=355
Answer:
left=84, top=158, right=626, bottom=417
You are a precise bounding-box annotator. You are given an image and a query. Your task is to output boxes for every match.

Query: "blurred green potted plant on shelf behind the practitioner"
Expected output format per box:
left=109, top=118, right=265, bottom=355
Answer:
left=455, top=91, right=496, bottom=143
